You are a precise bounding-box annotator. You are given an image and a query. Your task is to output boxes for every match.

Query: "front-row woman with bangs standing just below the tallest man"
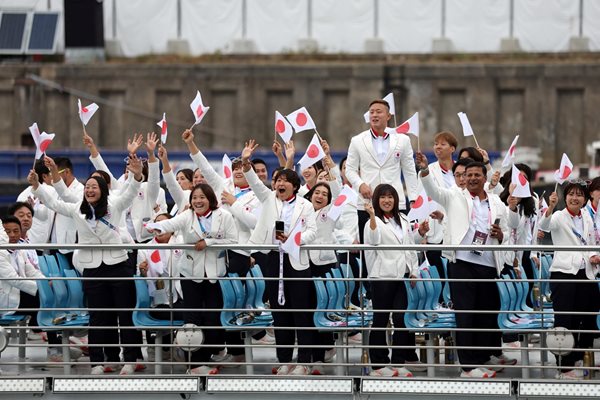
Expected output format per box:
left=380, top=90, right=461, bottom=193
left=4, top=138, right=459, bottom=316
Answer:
left=364, top=184, right=427, bottom=377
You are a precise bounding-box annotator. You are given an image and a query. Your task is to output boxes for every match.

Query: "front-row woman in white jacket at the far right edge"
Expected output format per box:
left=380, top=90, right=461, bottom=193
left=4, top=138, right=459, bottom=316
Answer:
left=540, top=181, right=600, bottom=379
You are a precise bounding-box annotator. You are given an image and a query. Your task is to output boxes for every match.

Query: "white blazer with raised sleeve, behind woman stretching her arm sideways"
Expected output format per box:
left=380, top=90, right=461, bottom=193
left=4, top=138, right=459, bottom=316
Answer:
left=190, top=151, right=262, bottom=256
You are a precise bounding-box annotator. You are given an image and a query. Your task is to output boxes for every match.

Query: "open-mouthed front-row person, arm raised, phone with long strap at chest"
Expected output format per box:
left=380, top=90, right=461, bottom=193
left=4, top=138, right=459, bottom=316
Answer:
left=241, top=139, right=317, bottom=375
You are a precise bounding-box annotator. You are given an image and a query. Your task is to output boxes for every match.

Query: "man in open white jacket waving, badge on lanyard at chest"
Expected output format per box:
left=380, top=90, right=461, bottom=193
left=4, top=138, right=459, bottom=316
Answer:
left=416, top=152, right=516, bottom=378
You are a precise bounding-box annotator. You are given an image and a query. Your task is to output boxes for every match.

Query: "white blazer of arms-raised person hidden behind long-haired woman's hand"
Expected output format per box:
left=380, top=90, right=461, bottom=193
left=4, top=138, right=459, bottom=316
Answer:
left=90, top=155, right=167, bottom=242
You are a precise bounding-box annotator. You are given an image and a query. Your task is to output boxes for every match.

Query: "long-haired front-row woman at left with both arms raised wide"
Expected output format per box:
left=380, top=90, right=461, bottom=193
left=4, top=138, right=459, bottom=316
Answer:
left=27, top=155, right=143, bottom=375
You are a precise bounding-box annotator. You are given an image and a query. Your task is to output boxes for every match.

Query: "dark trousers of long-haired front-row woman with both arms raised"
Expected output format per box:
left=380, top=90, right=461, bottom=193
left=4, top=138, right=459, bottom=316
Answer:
left=83, top=262, right=142, bottom=364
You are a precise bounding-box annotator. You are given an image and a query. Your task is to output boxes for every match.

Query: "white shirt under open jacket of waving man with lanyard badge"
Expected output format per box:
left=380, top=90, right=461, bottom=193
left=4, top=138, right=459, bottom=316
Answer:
left=456, top=196, right=496, bottom=268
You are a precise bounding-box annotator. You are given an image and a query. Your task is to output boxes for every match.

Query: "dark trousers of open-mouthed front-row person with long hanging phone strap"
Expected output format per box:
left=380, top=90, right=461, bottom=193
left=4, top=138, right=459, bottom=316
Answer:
left=265, top=251, right=316, bottom=364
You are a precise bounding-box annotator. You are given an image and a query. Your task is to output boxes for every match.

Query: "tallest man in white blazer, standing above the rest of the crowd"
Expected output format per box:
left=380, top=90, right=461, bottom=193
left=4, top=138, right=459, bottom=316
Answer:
left=346, top=100, right=418, bottom=243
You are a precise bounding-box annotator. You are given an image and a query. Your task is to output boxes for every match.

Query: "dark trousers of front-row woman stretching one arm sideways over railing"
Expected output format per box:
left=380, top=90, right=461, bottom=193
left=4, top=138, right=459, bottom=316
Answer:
left=181, top=278, right=225, bottom=367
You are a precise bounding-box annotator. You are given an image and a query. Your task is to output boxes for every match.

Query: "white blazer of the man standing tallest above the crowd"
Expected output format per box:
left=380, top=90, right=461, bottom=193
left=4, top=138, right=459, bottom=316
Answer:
left=346, top=128, right=418, bottom=210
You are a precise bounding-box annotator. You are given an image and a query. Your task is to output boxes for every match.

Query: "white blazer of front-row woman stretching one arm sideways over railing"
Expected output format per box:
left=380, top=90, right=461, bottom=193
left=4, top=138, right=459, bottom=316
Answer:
left=155, top=208, right=238, bottom=283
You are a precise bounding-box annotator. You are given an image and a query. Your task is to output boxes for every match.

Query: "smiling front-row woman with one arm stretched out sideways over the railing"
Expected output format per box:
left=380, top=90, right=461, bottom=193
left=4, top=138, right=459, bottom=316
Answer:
left=148, top=183, right=238, bottom=375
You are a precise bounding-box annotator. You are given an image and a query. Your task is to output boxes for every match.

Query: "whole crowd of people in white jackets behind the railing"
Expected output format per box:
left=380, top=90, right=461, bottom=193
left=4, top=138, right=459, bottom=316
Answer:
left=0, top=100, right=600, bottom=379
